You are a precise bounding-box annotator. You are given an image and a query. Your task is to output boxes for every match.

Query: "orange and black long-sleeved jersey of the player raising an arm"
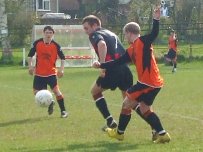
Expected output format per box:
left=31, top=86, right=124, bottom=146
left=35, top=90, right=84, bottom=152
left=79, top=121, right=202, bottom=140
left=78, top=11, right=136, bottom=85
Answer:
left=101, top=20, right=163, bottom=88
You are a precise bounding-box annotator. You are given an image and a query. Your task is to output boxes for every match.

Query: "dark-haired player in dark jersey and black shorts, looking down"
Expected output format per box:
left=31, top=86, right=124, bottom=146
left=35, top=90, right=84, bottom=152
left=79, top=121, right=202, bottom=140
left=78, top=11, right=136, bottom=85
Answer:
left=82, top=15, right=133, bottom=129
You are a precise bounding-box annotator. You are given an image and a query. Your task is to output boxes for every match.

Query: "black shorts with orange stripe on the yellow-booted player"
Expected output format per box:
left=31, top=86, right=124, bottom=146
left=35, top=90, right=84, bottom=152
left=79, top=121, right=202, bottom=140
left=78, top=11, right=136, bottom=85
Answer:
left=127, top=82, right=161, bottom=106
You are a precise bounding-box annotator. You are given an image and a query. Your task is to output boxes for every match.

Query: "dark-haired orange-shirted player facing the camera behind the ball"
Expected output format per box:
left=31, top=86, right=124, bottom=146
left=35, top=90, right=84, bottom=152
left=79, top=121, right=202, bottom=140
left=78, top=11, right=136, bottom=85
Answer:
left=28, top=26, right=68, bottom=118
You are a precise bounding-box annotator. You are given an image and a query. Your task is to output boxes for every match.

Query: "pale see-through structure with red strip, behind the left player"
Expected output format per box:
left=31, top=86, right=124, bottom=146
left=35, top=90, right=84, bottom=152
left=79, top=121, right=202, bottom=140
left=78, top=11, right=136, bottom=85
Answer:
left=32, top=25, right=96, bottom=67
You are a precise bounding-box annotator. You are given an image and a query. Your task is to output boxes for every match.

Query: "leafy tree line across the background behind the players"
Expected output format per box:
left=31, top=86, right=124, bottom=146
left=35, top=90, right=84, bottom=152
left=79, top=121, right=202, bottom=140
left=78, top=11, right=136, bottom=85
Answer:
left=0, top=0, right=203, bottom=63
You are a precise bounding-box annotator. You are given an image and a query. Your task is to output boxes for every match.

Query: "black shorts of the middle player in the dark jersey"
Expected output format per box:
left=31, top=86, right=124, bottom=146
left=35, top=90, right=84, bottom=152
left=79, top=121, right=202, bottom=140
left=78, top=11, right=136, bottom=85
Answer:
left=96, top=65, right=133, bottom=91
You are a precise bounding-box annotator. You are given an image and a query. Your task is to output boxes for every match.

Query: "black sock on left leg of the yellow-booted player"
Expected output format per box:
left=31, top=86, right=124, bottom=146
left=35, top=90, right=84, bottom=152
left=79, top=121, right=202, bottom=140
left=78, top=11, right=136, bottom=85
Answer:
left=117, top=114, right=131, bottom=134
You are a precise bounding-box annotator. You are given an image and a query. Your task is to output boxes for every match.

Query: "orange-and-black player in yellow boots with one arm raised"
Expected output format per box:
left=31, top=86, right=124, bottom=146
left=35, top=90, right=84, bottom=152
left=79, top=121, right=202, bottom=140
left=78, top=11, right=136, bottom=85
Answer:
left=94, top=8, right=171, bottom=143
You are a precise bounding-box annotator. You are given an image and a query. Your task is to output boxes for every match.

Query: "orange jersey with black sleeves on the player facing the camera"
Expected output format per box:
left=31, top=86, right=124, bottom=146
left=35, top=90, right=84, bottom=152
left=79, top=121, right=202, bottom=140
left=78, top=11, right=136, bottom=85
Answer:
left=28, top=38, right=65, bottom=77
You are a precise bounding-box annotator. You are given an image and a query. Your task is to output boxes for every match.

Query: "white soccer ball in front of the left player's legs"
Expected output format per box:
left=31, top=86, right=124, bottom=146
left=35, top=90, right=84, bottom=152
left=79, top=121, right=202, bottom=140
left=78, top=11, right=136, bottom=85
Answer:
left=35, top=90, right=53, bottom=107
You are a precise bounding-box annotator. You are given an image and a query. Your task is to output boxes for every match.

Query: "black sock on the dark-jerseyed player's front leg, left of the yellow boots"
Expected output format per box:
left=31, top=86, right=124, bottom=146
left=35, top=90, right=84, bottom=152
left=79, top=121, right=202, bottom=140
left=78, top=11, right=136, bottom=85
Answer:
left=96, top=98, right=113, bottom=121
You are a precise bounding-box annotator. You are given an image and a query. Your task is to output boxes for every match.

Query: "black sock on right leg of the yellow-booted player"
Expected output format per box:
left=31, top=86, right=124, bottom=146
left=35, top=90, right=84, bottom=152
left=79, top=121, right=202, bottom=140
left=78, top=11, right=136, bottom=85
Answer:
left=146, top=112, right=164, bottom=132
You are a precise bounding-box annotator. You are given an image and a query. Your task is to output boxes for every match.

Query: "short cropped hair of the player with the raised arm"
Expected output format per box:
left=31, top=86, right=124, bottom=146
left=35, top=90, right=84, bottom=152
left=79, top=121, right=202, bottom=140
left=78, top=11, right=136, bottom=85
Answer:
left=123, top=22, right=140, bottom=34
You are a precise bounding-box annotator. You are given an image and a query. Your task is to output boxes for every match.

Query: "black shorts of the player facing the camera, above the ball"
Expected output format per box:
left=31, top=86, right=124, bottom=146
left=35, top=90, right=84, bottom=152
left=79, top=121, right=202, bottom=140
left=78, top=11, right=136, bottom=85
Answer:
left=33, top=75, right=57, bottom=90
